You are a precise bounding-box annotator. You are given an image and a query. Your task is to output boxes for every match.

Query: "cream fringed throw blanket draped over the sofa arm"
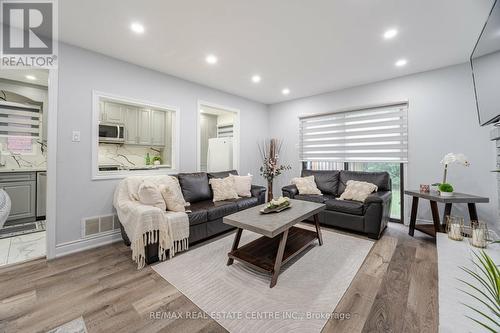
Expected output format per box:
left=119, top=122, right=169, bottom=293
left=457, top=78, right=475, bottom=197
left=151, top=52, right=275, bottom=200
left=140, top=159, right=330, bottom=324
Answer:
left=113, top=176, right=189, bottom=269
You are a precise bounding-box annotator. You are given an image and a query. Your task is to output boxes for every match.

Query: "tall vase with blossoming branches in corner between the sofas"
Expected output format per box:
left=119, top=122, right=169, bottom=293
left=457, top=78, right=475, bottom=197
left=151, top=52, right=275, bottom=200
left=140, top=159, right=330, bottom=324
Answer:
left=259, top=139, right=292, bottom=201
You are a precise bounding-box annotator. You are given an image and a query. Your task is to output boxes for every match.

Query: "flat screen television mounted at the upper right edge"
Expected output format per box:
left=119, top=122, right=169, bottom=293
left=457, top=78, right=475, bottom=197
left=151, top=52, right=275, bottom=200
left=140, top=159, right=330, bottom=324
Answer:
left=470, top=0, right=500, bottom=126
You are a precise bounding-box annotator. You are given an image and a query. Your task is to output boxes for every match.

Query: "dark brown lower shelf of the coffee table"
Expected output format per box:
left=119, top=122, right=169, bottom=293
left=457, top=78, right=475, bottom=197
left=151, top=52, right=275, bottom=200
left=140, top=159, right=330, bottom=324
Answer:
left=227, top=227, right=318, bottom=274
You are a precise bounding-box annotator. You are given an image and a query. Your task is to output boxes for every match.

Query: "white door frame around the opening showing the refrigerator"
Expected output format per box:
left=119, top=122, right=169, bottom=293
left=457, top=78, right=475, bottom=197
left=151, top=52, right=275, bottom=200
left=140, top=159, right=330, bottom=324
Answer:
left=196, top=99, right=241, bottom=172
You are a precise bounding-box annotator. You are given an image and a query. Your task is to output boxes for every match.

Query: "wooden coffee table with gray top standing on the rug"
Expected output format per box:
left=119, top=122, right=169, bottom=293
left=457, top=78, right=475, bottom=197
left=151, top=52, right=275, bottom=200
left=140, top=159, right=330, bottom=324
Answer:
left=223, top=200, right=326, bottom=288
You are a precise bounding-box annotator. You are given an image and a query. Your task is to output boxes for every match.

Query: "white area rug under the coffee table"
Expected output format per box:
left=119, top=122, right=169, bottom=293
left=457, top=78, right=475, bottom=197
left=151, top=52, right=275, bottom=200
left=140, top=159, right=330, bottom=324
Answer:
left=153, top=224, right=373, bottom=333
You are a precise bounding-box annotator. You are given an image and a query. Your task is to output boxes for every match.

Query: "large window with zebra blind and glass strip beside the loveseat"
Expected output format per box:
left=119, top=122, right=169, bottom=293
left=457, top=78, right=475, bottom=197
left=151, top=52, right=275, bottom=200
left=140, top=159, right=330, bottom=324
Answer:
left=299, top=103, right=408, bottom=222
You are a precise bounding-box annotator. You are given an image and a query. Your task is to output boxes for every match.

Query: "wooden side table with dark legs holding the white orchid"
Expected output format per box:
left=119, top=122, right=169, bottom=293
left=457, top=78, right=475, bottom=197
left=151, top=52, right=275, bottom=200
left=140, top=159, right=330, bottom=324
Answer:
left=405, top=191, right=490, bottom=237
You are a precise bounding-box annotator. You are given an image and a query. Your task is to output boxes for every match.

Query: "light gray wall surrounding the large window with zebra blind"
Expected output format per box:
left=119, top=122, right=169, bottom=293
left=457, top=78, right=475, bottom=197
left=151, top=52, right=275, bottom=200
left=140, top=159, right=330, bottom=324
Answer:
left=269, top=64, right=498, bottom=229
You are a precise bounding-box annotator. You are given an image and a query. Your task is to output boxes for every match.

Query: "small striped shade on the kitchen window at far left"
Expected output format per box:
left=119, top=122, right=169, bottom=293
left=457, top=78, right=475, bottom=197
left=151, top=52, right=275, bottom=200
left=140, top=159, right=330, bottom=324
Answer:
left=0, top=102, right=42, bottom=137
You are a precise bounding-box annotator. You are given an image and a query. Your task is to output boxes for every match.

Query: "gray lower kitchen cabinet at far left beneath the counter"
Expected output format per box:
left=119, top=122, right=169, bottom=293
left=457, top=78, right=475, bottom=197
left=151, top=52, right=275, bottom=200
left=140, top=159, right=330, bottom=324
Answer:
left=0, top=172, right=36, bottom=224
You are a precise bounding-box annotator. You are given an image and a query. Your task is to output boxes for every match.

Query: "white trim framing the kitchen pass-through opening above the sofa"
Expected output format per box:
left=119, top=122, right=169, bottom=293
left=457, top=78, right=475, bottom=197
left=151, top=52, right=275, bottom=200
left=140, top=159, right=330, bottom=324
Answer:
left=92, top=90, right=180, bottom=180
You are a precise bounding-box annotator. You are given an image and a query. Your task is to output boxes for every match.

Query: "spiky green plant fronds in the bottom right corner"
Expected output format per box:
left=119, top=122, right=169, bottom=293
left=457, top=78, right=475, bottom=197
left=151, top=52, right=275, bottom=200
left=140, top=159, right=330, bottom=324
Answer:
left=459, top=246, right=500, bottom=332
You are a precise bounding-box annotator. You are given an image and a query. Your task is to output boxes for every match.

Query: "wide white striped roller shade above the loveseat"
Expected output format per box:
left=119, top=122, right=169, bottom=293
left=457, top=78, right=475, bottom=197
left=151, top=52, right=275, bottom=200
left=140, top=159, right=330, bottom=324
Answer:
left=299, top=103, right=408, bottom=163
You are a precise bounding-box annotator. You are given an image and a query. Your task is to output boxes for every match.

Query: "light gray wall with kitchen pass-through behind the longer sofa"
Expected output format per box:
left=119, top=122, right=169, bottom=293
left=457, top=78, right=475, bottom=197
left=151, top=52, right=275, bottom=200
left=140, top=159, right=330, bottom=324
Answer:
left=56, top=44, right=268, bottom=244
